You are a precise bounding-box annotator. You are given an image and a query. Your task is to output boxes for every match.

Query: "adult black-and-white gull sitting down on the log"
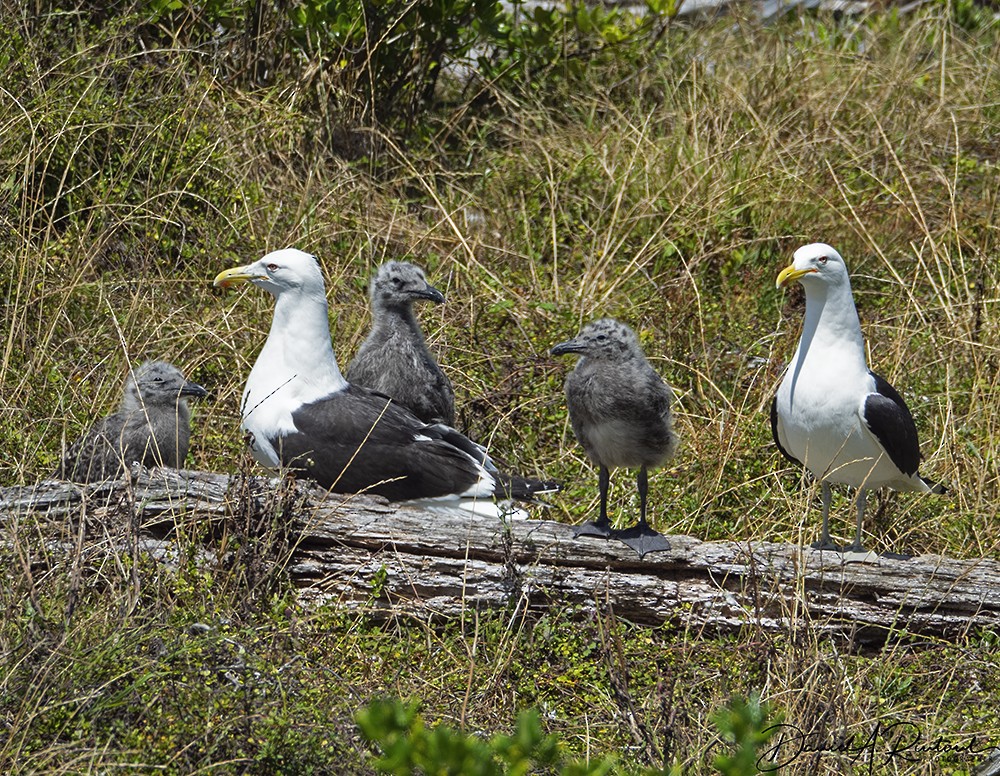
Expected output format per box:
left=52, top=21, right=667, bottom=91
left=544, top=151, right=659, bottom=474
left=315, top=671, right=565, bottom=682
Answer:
left=215, top=248, right=558, bottom=511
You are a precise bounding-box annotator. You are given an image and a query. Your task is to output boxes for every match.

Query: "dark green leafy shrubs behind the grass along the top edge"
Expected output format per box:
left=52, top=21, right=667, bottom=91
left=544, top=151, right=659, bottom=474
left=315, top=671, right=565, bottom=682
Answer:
left=39, top=0, right=678, bottom=131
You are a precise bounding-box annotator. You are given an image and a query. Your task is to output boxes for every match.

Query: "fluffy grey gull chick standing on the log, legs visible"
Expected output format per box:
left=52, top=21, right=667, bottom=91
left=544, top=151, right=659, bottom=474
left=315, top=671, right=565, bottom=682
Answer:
left=552, top=318, right=677, bottom=557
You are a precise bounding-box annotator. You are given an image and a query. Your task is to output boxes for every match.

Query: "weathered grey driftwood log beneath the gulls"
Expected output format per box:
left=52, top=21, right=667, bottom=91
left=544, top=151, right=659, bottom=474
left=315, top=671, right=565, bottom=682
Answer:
left=0, top=469, right=1000, bottom=646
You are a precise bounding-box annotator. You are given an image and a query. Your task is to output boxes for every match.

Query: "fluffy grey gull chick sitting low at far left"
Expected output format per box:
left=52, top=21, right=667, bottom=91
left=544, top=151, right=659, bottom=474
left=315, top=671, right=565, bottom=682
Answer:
left=59, top=361, right=206, bottom=482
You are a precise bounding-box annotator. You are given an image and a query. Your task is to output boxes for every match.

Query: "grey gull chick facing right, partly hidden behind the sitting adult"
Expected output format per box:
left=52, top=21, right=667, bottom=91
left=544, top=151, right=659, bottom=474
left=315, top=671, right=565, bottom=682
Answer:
left=346, top=261, right=455, bottom=426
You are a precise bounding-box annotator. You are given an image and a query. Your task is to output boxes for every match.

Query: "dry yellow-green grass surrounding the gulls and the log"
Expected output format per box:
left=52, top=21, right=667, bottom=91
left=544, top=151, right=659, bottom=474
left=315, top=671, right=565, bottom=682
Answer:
left=0, top=6, right=1000, bottom=774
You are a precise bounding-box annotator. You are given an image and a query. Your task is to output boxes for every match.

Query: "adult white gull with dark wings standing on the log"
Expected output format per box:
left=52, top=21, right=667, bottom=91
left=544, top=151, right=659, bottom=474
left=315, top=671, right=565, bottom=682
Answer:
left=771, top=243, right=945, bottom=552
